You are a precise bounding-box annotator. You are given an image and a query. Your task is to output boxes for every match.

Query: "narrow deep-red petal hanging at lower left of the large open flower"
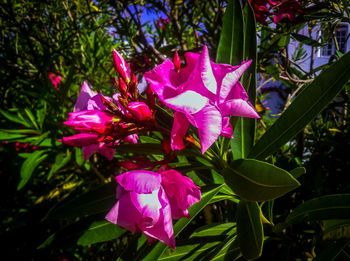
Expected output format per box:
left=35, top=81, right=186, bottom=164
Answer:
left=171, top=111, right=189, bottom=150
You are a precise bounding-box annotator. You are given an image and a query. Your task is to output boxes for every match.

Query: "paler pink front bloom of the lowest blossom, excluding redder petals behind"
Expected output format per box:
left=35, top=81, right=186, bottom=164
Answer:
left=106, top=170, right=175, bottom=248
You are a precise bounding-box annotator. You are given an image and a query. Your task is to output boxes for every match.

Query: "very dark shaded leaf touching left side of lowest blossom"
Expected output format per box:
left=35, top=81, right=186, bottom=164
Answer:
left=50, top=183, right=117, bottom=219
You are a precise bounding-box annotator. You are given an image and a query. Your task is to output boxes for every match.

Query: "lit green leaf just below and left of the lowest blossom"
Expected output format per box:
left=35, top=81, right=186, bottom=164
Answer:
left=77, top=220, right=126, bottom=246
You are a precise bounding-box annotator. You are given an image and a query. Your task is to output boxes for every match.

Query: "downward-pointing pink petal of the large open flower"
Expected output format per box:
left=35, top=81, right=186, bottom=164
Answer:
left=193, top=105, right=222, bottom=154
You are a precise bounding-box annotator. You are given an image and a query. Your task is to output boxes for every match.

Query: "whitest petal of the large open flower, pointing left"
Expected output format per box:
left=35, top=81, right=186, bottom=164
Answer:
left=164, top=91, right=208, bottom=114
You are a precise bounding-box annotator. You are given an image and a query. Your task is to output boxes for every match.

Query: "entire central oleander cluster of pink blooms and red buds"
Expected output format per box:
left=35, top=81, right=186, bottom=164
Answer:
left=62, top=46, right=259, bottom=248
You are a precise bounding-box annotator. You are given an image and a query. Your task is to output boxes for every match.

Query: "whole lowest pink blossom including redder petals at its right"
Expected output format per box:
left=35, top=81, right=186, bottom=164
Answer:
left=106, top=170, right=200, bottom=248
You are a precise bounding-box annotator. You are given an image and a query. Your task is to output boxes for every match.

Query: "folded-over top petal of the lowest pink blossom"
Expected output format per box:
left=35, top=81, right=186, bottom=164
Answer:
left=115, top=170, right=161, bottom=193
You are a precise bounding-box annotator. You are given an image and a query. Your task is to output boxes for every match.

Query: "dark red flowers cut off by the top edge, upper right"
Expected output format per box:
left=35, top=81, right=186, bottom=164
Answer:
left=249, top=0, right=303, bottom=24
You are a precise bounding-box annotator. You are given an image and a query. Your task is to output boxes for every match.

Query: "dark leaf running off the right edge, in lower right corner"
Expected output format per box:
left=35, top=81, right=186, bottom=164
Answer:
left=285, top=194, right=350, bottom=224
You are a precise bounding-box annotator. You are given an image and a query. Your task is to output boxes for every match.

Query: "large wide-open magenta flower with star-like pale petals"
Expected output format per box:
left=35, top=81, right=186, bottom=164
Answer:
left=144, top=46, right=259, bottom=153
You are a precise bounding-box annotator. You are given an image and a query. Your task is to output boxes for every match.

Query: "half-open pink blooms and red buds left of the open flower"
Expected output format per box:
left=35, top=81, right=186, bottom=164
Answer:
left=62, top=50, right=153, bottom=160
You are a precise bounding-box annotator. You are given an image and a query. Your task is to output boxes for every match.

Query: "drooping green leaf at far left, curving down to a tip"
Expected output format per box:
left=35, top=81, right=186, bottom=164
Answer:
left=17, top=150, right=48, bottom=190
